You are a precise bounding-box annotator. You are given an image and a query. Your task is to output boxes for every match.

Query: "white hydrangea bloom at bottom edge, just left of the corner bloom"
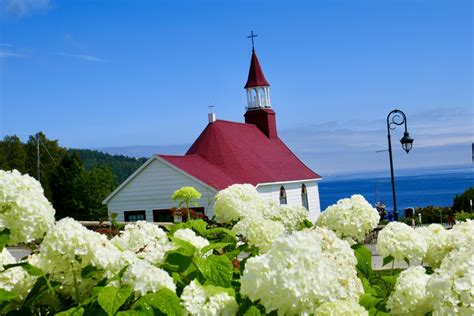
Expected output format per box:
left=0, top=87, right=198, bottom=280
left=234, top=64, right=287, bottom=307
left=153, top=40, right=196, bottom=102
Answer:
left=387, top=266, right=431, bottom=315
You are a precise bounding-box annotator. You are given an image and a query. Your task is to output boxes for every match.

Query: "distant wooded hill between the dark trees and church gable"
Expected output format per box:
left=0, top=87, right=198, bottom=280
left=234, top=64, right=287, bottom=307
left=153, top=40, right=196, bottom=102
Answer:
left=68, top=148, right=148, bottom=183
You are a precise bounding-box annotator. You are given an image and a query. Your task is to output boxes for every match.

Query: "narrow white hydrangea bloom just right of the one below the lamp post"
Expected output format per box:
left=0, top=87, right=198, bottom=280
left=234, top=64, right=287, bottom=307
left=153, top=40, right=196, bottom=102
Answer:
left=416, top=224, right=452, bottom=268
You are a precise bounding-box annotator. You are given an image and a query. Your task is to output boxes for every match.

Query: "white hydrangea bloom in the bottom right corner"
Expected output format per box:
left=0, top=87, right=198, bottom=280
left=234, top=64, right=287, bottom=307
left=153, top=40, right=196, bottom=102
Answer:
left=427, top=248, right=474, bottom=316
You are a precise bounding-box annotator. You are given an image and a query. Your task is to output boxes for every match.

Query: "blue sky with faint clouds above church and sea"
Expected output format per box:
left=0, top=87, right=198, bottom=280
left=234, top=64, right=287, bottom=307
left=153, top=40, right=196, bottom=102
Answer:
left=0, top=0, right=474, bottom=175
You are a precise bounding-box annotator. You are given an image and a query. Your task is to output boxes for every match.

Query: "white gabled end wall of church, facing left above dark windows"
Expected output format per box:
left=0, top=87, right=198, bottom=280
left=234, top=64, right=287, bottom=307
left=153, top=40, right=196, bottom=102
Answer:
left=107, top=158, right=215, bottom=221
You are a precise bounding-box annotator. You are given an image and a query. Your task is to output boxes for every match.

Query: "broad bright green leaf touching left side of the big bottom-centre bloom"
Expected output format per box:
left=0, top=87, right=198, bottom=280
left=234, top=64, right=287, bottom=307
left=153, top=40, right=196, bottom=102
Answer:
left=194, top=255, right=233, bottom=287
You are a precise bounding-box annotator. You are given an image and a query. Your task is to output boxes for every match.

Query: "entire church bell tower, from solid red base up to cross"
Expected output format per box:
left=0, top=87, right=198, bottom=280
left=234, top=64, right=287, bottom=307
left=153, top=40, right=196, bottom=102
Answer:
left=244, top=31, right=278, bottom=139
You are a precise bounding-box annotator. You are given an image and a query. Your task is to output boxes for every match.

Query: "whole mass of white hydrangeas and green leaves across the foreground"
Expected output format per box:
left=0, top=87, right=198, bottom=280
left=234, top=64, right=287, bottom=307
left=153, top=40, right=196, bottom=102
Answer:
left=0, top=171, right=474, bottom=316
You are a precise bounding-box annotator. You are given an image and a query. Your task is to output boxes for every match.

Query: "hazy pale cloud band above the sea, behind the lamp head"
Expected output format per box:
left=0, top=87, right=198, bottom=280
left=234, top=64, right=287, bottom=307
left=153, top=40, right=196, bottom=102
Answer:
left=279, top=107, right=474, bottom=172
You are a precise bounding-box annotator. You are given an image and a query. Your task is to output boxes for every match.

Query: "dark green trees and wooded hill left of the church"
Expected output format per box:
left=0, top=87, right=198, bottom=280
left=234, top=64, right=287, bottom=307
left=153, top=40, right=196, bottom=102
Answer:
left=0, top=132, right=146, bottom=220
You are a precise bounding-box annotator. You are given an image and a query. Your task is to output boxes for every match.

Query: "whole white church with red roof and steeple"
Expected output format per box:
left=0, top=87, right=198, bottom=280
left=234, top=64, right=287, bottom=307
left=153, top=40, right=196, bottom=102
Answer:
left=103, top=44, right=321, bottom=222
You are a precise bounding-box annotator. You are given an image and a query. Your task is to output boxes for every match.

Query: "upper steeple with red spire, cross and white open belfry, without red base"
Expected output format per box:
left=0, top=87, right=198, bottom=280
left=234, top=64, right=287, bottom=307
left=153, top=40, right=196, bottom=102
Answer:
left=244, top=31, right=271, bottom=110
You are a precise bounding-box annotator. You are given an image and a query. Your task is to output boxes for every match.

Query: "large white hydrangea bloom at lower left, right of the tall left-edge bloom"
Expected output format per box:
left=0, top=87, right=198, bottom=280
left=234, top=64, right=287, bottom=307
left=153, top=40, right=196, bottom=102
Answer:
left=35, top=218, right=123, bottom=300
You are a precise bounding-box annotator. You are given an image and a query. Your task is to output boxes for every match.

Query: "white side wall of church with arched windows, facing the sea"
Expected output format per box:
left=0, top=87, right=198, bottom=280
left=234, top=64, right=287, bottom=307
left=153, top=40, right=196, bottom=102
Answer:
left=257, top=180, right=321, bottom=221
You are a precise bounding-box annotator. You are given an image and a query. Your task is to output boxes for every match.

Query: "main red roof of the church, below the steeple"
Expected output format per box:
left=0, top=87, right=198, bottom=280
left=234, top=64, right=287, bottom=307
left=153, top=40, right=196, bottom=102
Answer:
left=159, top=120, right=320, bottom=190
